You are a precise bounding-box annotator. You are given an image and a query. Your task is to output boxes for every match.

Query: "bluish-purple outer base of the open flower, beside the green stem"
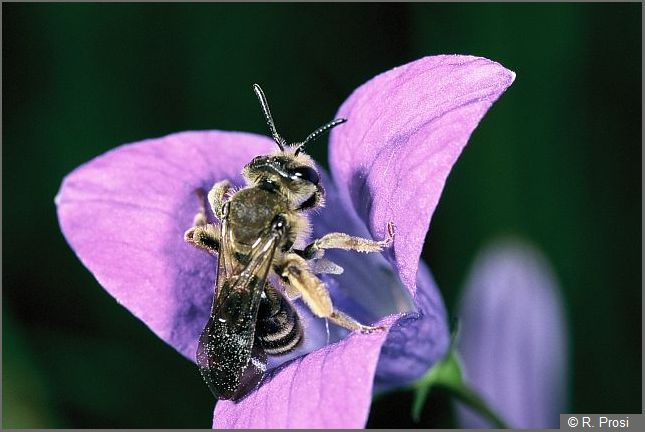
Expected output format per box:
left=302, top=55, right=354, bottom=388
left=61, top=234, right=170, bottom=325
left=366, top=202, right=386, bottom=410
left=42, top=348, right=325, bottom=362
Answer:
left=374, top=262, right=450, bottom=392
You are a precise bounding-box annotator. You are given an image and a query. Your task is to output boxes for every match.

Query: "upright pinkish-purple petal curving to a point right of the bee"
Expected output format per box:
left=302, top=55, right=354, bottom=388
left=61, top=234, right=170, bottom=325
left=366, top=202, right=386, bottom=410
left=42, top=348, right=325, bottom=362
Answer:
left=330, top=55, right=515, bottom=292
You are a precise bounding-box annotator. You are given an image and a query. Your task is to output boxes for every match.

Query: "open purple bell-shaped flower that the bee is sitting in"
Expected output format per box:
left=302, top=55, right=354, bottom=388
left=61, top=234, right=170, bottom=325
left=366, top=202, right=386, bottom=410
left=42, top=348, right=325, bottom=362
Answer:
left=56, top=56, right=515, bottom=428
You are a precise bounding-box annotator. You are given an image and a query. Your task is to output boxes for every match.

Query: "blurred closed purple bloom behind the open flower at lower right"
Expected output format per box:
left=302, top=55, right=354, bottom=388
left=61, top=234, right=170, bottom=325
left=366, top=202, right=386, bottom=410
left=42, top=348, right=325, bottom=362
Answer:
left=459, top=240, right=567, bottom=429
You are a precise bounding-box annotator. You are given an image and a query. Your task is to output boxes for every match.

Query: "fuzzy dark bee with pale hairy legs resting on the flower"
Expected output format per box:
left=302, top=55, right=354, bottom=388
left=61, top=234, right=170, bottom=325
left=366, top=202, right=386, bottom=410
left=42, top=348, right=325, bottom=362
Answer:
left=184, top=84, right=394, bottom=400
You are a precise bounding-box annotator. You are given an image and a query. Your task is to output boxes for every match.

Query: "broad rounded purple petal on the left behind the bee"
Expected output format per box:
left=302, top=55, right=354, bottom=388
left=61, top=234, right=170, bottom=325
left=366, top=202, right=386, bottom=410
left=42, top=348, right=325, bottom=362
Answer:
left=56, top=131, right=275, bottom=361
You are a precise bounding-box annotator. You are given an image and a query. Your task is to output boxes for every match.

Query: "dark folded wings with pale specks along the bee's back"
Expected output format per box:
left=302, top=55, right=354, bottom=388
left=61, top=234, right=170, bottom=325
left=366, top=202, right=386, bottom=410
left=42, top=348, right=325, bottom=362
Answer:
left=197, top=224, right=282, bottom=399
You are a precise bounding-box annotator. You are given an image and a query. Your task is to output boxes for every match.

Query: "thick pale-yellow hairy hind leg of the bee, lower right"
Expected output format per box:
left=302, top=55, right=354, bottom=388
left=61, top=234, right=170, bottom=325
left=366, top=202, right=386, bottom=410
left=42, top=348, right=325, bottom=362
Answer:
left=280, top=253, right=384, bottom=333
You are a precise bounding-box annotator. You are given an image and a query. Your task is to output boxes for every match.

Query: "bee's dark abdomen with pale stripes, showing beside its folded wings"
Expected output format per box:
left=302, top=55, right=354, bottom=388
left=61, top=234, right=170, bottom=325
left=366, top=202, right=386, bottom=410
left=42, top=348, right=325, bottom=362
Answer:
left=256, top=288, right=303, bottom=356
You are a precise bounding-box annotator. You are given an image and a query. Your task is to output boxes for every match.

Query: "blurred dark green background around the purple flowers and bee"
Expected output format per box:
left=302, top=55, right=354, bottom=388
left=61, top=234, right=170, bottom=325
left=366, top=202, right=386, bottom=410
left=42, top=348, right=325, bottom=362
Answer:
left=2, top=3, right=642, bottom=428
